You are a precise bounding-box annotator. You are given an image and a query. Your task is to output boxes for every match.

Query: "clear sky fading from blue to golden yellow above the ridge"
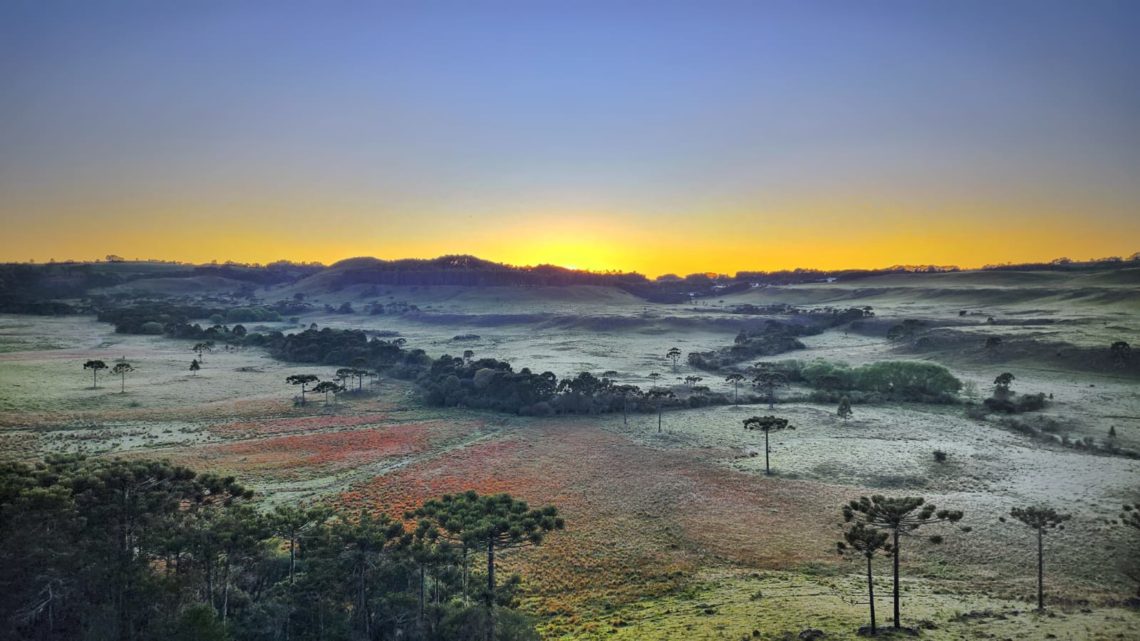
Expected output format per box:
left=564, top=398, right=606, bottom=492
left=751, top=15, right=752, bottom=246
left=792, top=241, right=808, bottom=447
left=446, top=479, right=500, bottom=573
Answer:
left=0, top=0, right=1140, bottom=276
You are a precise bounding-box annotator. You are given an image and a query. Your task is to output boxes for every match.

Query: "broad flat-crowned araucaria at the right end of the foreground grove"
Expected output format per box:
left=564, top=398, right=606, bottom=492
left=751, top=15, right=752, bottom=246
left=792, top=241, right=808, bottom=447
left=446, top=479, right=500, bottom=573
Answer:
left=412, top=492, right=565, bottom=639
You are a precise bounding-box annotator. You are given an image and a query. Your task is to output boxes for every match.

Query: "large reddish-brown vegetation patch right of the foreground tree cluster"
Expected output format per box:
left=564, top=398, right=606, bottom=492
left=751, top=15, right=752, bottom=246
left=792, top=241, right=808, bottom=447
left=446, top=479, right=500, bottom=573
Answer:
left=335, top=421, right=844, bottom=615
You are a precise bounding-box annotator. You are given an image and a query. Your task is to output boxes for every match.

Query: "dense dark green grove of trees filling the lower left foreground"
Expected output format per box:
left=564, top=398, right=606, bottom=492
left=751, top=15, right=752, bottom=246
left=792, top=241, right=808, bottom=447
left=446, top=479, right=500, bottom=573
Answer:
left=0, top=457, right=563, bottom=641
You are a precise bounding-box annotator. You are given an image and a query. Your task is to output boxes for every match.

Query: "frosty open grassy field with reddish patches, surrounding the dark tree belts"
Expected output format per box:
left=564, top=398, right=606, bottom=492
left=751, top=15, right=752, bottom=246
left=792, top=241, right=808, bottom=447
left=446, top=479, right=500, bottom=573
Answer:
left=0, top=270, right=1140, bottom=640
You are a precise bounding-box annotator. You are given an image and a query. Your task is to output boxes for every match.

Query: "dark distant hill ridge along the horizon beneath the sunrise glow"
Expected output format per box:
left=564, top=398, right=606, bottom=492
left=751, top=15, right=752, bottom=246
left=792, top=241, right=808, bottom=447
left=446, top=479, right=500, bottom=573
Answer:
left=0, top=254, right=1140, bottom=313
